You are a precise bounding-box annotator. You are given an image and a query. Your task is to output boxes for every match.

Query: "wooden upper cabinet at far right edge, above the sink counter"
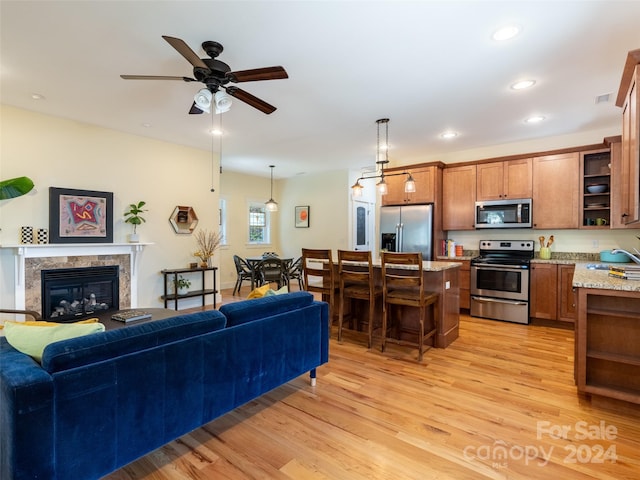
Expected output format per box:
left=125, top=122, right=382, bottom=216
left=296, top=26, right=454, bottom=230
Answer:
left=616, top=49, right=640, bottom=224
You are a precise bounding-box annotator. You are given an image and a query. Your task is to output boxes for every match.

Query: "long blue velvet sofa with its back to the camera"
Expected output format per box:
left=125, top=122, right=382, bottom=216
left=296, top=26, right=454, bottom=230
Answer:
left=0, top=292, right=329, bottom=480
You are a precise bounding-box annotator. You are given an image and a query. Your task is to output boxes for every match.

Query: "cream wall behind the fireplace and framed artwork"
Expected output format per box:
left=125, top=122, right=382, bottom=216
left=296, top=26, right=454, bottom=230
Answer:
left=0, top=106, right=219, bottom=308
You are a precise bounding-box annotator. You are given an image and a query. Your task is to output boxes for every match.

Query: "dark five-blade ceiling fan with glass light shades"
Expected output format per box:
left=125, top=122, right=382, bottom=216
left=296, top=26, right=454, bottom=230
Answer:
left=120, top=35, right=289, bottom=114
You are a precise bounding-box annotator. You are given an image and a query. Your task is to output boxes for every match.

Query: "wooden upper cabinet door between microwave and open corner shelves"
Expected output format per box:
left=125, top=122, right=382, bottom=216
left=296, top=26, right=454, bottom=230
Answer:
left=533, top=152, right=582, bottom=229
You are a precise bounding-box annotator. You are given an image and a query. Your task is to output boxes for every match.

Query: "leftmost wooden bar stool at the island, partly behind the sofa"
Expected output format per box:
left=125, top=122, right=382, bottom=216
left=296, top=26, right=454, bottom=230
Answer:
left=302, top=248, right=339, bottom=336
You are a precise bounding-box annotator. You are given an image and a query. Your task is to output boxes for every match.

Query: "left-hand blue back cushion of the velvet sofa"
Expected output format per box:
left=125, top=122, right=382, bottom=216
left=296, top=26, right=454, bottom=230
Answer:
left=42, top=310, right=226, bottom=373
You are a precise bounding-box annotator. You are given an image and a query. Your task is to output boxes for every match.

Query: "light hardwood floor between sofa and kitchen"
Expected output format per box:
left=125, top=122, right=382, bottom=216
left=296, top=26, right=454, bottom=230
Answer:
left=106, top=288, right=640, bottom=480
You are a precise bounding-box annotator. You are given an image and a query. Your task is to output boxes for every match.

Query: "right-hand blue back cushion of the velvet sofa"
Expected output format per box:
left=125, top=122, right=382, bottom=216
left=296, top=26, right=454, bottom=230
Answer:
left=220, top=292, right=313, bottom=327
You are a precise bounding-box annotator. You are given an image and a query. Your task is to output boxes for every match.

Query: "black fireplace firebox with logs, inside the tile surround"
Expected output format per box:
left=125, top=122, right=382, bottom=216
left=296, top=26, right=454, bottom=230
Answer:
left=41, top=265, right=120, bottom=322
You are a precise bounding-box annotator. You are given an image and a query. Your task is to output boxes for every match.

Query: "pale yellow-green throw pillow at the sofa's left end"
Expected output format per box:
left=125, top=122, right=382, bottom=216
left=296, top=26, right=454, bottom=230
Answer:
left=4, top=319, right=104, bottom=362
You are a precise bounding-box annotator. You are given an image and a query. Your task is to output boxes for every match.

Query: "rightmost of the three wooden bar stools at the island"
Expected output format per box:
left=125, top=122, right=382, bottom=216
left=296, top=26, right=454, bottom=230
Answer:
left=381, top=252, right=439, bottom=362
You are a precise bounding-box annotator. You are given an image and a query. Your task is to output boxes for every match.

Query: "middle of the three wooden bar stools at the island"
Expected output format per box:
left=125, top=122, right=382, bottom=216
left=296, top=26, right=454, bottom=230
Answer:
left=338, top=250, right=382, bottom=348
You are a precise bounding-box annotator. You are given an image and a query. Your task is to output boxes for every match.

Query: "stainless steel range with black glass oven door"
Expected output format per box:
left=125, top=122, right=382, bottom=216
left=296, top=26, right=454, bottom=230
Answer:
left=471, top=240, right=534, bottom=324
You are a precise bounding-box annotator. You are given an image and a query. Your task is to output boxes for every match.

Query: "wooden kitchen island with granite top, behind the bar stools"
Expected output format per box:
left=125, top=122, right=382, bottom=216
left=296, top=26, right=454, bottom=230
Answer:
left=333, top=259, right=462, bottom=348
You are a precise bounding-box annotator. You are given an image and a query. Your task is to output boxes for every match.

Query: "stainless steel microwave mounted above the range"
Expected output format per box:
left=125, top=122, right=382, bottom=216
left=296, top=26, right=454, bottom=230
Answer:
left=476, top=198, right=532, bottom=228
